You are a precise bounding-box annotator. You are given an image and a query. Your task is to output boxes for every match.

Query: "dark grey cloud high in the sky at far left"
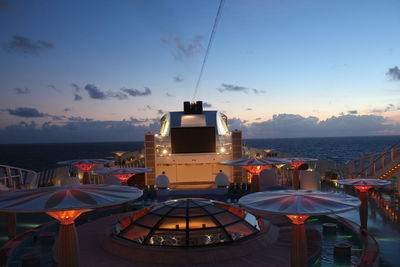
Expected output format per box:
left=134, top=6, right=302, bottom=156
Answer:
left=3, top=35, right=54, bottom=55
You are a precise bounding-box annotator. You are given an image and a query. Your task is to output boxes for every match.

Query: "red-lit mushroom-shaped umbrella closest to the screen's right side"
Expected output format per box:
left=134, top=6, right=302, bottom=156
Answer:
left=219, top=158, right=289, bottom=192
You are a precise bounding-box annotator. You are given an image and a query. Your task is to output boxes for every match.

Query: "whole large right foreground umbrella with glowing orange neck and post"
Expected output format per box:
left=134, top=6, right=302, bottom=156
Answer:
left=239, top=190, right=360, bottom=266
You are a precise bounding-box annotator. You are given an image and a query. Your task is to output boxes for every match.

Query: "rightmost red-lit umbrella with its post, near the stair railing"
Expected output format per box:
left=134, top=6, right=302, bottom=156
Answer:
left=337, top=178, right=390, bottom=230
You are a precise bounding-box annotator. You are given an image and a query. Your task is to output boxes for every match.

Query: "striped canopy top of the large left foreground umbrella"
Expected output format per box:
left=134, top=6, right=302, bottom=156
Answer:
left=0, top=185, right=142, bottom=212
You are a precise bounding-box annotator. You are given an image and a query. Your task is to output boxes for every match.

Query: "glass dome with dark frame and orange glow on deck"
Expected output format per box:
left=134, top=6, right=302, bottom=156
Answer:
left=118, top=199, right=260, bottom=247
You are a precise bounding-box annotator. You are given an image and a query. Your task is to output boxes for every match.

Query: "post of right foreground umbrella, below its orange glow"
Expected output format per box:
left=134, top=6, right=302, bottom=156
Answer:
left=290, top=223, right=307, bottom=267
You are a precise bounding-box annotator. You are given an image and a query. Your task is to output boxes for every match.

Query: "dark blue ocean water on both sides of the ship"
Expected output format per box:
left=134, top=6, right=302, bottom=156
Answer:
left=0, top=136, right=400, bottom=171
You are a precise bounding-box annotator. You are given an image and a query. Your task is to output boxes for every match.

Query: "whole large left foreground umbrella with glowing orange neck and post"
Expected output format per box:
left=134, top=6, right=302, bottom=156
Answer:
left=0, top=185, right=142, bottom=267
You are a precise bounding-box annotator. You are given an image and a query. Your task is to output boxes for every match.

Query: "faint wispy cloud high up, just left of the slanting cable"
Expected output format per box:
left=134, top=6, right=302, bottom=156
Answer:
left=161, top=35, right=204, bottom=61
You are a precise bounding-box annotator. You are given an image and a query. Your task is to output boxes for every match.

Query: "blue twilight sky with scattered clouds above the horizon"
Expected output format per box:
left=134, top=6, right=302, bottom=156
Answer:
left=0, top=0, right=400, bottom=143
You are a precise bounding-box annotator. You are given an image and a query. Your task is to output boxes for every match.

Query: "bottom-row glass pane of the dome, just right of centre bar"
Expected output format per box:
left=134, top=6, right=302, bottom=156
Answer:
left=189, top=228, right=230, bottom=246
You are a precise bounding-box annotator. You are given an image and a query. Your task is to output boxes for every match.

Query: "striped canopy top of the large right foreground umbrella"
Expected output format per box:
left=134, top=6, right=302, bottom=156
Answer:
left=239, top=190, right=361, bottom=217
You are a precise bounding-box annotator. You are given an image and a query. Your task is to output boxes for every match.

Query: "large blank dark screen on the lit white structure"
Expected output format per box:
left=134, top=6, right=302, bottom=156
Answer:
left=171, top=127, right=215, bottom=154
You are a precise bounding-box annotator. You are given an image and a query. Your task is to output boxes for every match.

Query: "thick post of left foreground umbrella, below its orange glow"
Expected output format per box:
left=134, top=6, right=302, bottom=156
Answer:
left=55, top=223, right=79, bottom=267
